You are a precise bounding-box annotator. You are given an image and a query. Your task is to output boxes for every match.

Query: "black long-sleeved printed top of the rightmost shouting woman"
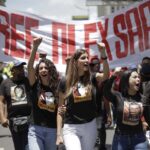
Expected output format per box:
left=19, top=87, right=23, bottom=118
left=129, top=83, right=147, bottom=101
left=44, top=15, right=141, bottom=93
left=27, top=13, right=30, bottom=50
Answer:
left=104, top=77, right=143, bottom=134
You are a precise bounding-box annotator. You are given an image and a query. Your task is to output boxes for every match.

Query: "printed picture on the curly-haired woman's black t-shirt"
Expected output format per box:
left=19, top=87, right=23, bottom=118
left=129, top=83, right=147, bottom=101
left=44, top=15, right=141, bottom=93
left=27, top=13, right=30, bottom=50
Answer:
left=38, top=92, right=56, bottom=112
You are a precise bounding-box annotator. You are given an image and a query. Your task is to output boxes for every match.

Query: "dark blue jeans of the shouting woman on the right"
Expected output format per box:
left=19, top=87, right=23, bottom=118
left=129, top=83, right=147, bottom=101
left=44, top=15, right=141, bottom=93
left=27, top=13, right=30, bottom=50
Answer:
left=112, top=133, right=148, bottom=150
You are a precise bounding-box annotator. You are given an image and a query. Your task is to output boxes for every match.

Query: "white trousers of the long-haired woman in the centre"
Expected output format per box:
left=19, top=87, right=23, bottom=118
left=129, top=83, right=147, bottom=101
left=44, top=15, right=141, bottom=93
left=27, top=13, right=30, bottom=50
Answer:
left=63, top=119, right=97, bottom=150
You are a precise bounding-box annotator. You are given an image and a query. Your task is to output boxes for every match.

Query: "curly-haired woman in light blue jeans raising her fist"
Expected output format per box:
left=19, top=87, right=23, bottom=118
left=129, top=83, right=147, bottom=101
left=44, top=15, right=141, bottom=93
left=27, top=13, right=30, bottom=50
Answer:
left=28, top=38, right=59, bottom=150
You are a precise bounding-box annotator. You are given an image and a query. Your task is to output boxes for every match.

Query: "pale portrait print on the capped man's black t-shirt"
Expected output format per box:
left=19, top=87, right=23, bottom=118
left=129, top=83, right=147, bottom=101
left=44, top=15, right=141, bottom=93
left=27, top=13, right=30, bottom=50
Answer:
left=10, top=85, right=27, bottom=106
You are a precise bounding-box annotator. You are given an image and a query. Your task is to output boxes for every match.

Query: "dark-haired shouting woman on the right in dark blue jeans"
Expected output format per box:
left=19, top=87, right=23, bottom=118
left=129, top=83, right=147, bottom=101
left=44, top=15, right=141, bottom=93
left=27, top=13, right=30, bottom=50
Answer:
left=104, top=68, right=148, bottom=150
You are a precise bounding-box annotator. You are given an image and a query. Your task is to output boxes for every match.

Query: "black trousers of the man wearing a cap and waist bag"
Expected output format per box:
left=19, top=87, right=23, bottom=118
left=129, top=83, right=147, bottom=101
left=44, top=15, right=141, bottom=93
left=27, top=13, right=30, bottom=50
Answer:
left=9, top=120, right=28, bottom=150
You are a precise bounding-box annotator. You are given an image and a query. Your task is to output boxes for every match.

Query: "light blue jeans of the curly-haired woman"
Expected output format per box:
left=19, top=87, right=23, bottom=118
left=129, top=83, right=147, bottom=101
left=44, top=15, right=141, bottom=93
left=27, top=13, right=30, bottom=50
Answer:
left=28, top=125, right=56, bottom=150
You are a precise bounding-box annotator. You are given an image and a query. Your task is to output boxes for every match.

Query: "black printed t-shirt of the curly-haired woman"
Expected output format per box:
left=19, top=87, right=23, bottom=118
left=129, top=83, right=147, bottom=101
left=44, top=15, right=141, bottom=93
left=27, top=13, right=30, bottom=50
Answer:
left=30, top=82, right=57, bottom=128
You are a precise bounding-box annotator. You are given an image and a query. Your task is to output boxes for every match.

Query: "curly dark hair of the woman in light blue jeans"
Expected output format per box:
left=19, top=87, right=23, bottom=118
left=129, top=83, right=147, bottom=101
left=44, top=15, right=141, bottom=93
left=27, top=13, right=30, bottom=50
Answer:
left=36, top=58, right=59, bottom=93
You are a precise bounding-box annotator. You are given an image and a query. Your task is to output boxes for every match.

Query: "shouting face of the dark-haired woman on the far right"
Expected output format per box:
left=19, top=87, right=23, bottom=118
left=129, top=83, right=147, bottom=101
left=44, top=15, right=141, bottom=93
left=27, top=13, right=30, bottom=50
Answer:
left=129, top=71, right=140, bottom=93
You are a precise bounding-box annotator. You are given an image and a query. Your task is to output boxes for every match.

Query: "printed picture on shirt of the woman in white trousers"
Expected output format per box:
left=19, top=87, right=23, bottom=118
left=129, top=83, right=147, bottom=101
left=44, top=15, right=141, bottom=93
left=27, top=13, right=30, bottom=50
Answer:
left=73, top=83, right=92, bottom=103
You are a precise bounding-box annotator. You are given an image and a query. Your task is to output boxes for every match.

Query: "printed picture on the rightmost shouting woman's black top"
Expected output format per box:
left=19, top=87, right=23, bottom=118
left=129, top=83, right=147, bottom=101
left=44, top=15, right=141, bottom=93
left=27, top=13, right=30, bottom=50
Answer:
left=122, top=101, right=143, bottom=126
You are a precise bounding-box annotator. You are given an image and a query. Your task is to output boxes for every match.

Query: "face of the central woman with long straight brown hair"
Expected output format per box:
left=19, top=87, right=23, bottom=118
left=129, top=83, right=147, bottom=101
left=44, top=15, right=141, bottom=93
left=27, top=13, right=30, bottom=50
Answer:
left=77, top=53, right=89, bottom=76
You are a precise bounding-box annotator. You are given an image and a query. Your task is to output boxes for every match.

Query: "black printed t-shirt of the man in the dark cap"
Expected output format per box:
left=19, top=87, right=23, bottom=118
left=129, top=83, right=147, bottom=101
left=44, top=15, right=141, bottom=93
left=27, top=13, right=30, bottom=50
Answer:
left=0, top=78, right=31, bottom=118
